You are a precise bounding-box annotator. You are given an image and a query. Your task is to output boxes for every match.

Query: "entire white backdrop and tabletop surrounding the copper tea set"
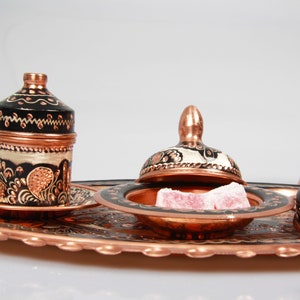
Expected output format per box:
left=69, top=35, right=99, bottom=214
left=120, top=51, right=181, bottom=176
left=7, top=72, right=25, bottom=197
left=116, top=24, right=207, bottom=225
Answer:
left=0, top=0, right=300, bottom=300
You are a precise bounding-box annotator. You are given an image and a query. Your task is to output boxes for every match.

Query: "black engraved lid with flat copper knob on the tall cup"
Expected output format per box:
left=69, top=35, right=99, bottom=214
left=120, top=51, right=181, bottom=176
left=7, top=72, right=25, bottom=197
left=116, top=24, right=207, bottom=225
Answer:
left=0, top=73, right=74, bottom=134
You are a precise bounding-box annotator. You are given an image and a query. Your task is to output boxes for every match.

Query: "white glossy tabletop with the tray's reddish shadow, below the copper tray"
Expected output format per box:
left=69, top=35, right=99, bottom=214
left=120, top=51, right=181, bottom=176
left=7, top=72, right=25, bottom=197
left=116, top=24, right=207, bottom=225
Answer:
left=0, top=240, right=300, bottom=300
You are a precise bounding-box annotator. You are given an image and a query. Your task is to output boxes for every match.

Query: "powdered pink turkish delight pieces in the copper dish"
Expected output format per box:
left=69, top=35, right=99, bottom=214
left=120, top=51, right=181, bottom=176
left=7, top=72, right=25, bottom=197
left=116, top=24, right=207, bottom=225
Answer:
left=156, top=182, right=250, bottom=210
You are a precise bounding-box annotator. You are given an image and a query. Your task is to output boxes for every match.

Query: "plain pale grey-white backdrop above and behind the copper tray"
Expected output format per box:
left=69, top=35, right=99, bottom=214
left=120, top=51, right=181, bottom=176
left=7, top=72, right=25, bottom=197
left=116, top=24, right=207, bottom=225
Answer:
left=0, top=0, right=300, bottom=183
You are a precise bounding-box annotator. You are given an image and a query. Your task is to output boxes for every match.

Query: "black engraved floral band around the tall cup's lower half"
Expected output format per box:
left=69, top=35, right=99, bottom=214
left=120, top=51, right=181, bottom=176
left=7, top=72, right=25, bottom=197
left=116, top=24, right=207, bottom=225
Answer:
left=0, top=160, right=71, bottom=206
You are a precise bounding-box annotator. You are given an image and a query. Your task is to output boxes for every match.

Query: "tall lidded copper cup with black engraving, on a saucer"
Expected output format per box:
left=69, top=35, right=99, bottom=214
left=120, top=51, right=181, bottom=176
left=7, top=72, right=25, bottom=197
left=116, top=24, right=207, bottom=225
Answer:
left=0, top=73, right=76, bottom=206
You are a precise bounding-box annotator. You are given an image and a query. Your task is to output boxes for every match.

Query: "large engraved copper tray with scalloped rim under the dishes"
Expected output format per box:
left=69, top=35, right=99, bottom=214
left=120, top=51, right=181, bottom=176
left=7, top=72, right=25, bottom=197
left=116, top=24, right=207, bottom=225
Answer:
left=0, top=180, right=300, bottom=258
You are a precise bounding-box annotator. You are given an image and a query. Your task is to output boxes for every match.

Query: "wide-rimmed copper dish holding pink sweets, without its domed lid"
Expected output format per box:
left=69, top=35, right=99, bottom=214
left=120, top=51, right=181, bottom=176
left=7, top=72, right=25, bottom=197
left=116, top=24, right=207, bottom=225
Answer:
left=95, top=183, right=294, bottom=239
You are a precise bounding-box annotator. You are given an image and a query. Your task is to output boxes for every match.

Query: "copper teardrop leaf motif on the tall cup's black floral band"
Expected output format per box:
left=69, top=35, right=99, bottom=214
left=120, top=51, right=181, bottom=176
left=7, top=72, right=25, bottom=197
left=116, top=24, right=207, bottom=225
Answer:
left=27, top=167, right=54, bottom=198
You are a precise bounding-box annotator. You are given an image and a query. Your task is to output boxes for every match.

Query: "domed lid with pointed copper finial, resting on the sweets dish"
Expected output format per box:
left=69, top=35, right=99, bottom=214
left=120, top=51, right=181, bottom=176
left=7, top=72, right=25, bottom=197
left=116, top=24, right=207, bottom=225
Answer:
left=136, top=105, right=245, bottom=185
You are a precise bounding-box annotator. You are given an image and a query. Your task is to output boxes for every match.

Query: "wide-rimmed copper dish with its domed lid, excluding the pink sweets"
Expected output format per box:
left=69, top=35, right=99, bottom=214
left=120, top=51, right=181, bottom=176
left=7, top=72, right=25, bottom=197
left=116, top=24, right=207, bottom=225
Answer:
left=95, top=106, right=294, bottom=239
